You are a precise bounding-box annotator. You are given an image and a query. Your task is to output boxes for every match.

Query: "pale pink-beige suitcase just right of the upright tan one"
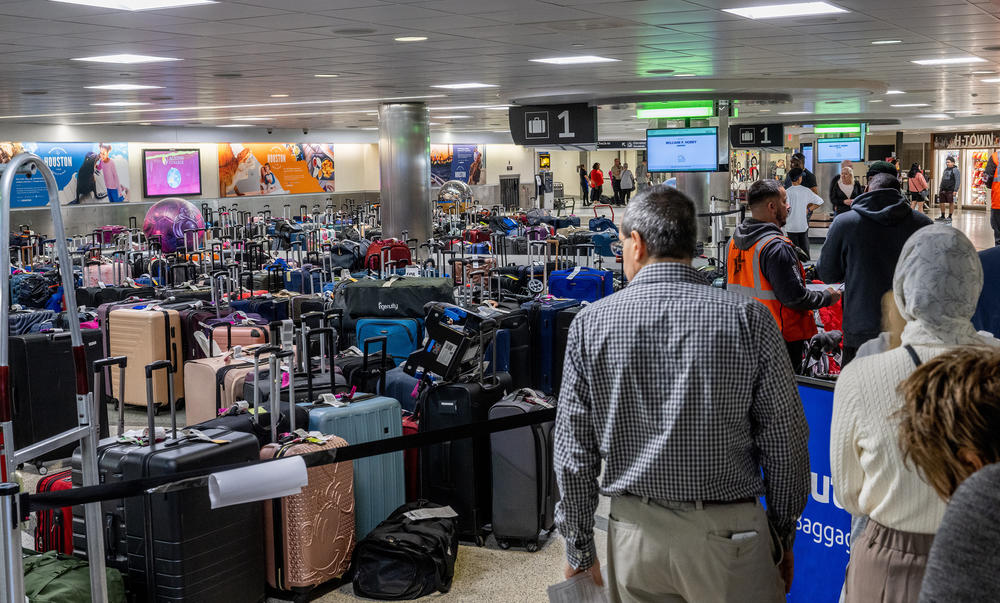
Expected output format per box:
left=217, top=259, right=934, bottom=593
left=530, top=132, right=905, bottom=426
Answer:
left=184, top=346, right=267, bottom=426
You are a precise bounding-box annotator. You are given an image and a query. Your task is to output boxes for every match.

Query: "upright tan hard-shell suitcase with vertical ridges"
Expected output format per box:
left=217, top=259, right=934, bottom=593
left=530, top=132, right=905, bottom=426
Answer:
left=108, top=308, right=184, bottom=408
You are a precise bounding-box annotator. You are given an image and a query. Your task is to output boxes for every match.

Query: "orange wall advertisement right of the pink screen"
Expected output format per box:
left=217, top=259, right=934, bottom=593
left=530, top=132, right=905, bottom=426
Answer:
left=219, top=142, right=335, bottom=197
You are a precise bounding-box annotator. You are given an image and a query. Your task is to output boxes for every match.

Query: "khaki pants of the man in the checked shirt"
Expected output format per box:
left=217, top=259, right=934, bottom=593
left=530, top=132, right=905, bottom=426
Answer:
left=608, top=496, right=785, bottom=603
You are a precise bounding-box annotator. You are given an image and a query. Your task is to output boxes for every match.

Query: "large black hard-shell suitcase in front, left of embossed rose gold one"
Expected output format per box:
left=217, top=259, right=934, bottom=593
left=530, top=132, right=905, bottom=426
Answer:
left=73, top=361, right=265, bottom=603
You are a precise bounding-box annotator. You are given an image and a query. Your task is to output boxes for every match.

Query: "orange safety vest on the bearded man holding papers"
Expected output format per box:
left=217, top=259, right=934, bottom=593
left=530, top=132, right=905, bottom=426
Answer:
left=726, top=234, right=816, bottom=341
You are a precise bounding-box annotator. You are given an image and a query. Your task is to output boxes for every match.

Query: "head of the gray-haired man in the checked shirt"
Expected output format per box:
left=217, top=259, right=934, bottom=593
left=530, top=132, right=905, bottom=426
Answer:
left=622, top=184, right=698, bottom=259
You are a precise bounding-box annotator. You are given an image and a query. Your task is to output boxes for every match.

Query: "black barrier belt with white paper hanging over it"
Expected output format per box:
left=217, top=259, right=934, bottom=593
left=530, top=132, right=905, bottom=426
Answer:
left=21, top=408, right=556, bottom=516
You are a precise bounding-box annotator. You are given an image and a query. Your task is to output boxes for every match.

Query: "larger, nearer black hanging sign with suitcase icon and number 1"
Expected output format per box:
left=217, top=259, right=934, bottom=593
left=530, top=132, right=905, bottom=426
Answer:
left=508, top=103, right=597, bottom=146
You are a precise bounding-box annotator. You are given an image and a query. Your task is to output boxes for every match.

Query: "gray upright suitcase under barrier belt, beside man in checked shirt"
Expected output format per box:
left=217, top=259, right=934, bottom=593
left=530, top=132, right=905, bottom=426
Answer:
left=489, top=389, right=559, bottom=552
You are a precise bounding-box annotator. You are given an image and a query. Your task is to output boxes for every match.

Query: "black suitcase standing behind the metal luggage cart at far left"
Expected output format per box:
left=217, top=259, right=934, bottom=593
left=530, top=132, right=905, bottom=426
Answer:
left=9, top=329, right=108, bottom=473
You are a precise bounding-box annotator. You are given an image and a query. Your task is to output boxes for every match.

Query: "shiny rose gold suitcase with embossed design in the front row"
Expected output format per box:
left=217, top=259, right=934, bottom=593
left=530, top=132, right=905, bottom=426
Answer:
left=260, top=436, right=354, bottom=591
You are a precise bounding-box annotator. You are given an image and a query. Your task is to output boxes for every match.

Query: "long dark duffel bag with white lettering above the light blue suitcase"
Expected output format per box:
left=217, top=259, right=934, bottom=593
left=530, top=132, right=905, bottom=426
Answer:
left=343, top=277, right=455, bottom=318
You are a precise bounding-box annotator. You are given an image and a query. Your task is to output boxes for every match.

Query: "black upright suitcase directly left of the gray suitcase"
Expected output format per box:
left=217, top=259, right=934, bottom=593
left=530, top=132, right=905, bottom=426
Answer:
left=420, top=360, right=511, bottom=546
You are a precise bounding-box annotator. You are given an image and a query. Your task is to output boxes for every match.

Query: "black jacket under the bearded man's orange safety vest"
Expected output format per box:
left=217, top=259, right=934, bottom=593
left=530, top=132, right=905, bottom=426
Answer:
left=733, top=218, right=831, bottom=310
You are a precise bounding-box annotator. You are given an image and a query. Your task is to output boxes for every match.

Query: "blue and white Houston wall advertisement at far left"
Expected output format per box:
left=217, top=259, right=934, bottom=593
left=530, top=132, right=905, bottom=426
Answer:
left=0, top=142, right=131, bottom=207
